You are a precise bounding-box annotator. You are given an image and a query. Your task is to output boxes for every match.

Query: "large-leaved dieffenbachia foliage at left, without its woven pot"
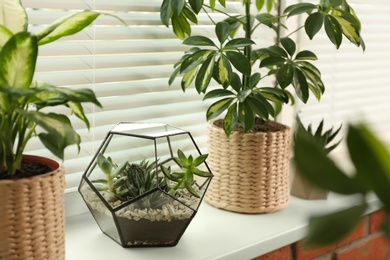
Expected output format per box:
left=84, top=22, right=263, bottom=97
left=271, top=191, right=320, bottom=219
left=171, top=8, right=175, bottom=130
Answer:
left=0, top=0, right=123, bottom=178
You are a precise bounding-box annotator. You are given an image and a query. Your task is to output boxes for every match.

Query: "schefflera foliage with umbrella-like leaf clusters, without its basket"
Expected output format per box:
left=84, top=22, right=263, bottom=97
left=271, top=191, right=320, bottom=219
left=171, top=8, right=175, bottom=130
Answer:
left=160, top=0, right=365, bottom=136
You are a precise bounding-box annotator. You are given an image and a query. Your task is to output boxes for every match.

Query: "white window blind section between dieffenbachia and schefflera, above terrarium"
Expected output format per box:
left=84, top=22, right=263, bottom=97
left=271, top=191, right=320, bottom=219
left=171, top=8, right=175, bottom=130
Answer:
left=22, top=0, right=272, bottom=192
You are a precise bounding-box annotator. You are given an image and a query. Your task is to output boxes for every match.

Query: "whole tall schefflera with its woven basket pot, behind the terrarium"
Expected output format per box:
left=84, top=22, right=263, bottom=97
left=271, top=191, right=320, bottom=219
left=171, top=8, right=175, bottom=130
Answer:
left=160, top=0, right=365, bottom=213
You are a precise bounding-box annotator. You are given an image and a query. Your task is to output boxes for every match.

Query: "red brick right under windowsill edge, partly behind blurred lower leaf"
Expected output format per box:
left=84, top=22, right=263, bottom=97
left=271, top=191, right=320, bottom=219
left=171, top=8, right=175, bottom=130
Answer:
left=293, top=220, right=365, bottom=260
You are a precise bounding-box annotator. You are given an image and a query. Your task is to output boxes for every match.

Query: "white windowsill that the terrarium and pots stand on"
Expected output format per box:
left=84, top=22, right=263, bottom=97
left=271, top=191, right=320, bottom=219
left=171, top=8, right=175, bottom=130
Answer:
left=66, top=193, right=380, bottom=260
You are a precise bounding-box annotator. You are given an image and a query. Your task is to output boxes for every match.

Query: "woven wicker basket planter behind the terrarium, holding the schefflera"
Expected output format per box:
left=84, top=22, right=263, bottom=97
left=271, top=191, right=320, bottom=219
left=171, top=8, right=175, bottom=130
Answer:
left=205, top=122, right=291, bottom=213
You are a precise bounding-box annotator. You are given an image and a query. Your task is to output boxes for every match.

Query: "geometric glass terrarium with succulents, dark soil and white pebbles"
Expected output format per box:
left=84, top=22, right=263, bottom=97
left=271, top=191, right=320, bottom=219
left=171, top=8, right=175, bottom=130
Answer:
left=79, top=122, right=212, bottom=247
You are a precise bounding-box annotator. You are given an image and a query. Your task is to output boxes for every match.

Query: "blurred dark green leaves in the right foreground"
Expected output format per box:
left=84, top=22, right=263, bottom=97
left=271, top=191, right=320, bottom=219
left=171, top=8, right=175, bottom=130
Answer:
left=294, top=123, right=390, bottom=246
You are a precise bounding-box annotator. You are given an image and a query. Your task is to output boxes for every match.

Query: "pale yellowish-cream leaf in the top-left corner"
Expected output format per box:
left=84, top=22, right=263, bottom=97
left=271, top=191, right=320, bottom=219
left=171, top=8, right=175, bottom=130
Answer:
left=0, top=0, right=28, bottom=34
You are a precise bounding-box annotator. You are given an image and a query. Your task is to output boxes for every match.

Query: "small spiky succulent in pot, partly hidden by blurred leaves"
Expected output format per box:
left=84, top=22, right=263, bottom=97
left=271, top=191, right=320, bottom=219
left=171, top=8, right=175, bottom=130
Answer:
left=290, top=116, right=341, bottom=200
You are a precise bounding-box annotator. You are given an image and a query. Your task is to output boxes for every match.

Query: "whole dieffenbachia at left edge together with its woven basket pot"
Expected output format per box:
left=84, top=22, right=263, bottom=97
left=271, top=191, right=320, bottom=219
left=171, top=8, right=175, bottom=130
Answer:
left=0, top=0, right=119, bottom=259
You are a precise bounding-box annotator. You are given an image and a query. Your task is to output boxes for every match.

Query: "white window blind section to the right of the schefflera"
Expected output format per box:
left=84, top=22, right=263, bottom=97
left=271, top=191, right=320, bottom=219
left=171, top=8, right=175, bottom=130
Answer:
left=297, top=0, right=390, bottom=155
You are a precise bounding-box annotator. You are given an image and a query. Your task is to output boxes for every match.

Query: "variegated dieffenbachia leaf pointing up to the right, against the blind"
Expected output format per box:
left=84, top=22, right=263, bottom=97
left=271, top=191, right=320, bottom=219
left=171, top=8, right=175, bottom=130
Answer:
left=36, top=11, right=100, bottom=45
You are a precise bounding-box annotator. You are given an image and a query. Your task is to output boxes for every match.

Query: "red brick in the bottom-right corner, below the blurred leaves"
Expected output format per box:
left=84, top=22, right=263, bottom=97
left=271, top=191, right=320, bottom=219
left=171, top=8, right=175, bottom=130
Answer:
left=334, top=234, right=390, bottom=260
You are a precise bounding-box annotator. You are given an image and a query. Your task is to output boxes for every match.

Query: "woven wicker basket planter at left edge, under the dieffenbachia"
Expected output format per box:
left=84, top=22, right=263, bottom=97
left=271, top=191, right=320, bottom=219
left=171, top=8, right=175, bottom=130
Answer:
left=0, top=155, right=65, bottom=260
